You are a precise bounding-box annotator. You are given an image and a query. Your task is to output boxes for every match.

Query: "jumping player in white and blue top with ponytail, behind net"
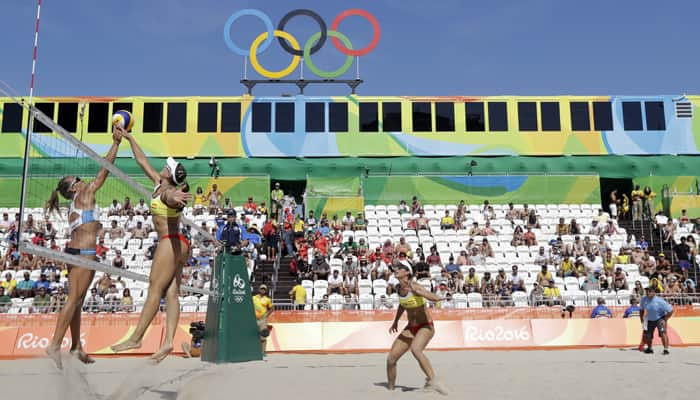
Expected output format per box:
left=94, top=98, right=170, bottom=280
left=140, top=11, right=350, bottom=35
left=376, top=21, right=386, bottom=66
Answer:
left=46, top=128, right=123, bottom=368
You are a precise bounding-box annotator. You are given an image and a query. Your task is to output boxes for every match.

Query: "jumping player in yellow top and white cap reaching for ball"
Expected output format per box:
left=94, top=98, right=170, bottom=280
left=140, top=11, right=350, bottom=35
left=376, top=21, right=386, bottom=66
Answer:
left=112, top=129, right=192, bottom=362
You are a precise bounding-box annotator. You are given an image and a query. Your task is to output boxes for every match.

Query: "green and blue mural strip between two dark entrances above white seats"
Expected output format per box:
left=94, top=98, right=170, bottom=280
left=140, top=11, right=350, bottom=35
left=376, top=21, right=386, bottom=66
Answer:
left=364, top=175, right=600, bottom=204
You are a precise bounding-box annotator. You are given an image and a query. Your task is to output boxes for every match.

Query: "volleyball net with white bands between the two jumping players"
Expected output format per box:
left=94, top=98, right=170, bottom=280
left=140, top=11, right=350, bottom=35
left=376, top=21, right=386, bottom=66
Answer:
left=0, top=86, right=218, bottom=295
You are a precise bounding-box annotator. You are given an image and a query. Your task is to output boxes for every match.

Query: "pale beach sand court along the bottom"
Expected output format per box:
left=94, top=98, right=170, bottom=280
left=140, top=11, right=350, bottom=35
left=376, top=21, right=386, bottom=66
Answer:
left=0, top=347, right=700, bottom=400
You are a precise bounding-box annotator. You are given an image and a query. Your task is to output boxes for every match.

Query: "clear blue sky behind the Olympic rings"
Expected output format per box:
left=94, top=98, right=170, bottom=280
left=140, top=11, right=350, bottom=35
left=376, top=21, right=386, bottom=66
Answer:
left=0, top=0, right=700, bottom=96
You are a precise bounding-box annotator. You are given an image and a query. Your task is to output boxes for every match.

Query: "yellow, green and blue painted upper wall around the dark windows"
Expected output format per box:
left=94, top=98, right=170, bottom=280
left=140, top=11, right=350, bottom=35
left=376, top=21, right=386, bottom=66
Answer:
left=0, top=96, right=700, bottom=158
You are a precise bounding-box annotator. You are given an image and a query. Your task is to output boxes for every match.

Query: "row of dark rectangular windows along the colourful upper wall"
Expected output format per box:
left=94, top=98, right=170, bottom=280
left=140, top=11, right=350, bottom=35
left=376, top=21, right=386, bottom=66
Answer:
left=1, top=101, right=666, bottom=133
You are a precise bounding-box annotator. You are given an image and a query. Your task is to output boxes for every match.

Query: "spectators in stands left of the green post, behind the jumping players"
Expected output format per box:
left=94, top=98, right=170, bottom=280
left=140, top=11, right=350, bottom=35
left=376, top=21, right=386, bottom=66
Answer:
left=0, top=184, right=283, bottom=313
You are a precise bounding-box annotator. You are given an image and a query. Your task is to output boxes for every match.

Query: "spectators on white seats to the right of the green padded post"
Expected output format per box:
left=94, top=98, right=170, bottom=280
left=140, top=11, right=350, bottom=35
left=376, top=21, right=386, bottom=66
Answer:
left=283, top=197, right=700, bottom=309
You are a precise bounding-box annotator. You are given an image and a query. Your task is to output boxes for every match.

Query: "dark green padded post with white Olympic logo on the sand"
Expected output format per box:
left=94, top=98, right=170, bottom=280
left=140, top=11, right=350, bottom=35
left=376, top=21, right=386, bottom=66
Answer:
left=202, top=254, right=262, bottom=363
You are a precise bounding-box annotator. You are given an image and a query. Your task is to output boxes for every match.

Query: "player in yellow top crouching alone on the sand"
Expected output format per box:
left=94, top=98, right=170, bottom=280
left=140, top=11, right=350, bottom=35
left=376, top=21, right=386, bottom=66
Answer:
left=386, top=261, right=446, bottom=394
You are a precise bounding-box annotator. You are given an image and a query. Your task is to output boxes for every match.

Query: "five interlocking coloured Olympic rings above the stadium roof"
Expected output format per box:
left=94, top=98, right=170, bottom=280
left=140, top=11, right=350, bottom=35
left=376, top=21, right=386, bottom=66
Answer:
left=224, top=9, right=381, bottom=79
